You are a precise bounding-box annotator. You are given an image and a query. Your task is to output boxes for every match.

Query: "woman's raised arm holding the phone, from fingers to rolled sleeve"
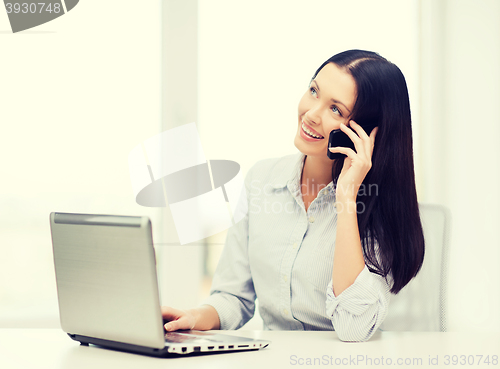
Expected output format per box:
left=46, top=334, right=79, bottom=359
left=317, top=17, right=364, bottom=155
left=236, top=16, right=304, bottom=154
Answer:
left=326, top=121, right=390, bottom=341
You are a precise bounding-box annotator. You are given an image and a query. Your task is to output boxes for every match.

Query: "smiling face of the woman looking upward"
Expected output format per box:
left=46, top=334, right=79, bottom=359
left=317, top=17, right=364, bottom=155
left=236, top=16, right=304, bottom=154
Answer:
left=294, top=63, right=357, bottom=161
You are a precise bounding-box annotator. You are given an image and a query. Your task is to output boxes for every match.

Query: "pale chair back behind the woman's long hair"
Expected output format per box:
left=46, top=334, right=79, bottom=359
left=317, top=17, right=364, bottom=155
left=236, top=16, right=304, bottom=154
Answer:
left=380, top=204, right=450, bottom=332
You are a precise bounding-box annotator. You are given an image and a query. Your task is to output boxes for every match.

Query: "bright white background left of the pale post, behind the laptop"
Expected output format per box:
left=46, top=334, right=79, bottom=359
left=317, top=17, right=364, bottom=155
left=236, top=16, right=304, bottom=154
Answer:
left=0, top=0, right=161, bottom=327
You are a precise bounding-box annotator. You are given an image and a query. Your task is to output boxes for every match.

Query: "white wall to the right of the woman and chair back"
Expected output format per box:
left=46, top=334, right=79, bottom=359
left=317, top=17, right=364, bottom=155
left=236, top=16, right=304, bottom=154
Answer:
left=418, top=0, right=500, bottom=331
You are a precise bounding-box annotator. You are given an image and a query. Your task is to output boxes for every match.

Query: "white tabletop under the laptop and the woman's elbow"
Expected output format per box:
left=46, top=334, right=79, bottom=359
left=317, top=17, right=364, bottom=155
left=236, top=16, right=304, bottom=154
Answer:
left=0, top=329, right=500, bottom=369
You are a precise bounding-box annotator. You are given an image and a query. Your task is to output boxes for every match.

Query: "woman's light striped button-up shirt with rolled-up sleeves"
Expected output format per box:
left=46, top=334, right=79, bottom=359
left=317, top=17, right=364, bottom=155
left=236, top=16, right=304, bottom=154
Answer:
left=204, top=153, right=391, bottom=341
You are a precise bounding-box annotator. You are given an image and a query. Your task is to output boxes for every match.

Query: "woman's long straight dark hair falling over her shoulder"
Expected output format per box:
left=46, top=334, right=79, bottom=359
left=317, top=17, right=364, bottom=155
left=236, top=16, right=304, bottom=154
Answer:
left=313, top=50, right=425, bottom=294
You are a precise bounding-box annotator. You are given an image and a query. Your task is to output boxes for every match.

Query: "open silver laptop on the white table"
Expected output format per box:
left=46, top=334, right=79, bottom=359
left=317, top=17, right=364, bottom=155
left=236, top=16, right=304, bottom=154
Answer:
left=50, top=213, right=270, bottom=357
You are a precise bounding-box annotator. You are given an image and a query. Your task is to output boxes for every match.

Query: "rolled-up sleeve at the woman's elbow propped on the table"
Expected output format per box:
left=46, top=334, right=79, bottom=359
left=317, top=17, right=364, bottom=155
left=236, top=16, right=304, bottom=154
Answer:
left=326, top=265, right=391, bottom=341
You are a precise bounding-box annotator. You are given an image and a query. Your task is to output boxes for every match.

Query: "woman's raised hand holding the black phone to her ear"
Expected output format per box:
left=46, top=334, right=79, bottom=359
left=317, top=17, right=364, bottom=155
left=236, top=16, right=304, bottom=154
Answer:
left=329, top=120, right=378, bottom=201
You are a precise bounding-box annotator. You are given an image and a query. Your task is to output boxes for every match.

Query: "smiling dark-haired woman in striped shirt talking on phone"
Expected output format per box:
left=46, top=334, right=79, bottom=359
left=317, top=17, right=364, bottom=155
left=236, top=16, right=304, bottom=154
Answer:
left=162, top=50, right=424, bottom=341
